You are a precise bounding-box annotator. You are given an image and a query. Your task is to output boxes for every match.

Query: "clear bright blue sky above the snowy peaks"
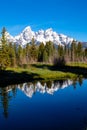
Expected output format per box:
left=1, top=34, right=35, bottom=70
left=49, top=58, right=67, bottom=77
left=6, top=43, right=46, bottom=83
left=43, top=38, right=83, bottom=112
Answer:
left=0, top=0, right=87, bottom=41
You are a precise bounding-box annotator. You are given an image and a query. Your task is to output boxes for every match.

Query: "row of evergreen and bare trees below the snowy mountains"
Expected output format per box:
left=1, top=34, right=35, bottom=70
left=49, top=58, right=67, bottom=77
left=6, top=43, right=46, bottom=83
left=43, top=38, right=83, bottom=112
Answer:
left=0, top=28, right=87, bottom=69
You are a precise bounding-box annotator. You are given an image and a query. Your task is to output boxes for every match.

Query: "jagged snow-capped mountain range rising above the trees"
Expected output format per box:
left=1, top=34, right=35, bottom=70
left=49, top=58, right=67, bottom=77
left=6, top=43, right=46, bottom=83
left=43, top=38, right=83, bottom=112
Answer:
left=6, top=26, right=73, bottom=46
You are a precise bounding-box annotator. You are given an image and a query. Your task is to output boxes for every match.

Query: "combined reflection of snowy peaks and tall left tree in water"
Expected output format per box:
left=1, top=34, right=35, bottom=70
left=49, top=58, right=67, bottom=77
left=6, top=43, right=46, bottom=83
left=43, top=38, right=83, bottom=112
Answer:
left=0, top=78, right=82, bottom=118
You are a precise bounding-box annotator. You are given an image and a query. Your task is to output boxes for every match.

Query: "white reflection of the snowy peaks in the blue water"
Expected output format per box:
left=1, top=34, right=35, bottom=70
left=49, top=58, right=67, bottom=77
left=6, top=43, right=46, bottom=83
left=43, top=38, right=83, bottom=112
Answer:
left=18, top=80, right=73, bottom=98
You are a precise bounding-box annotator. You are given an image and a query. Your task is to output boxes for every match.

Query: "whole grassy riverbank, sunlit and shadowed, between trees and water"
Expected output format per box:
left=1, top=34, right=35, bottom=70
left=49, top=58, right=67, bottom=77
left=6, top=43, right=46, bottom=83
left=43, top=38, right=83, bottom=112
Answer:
left=0, top=64, right=87, bottom=86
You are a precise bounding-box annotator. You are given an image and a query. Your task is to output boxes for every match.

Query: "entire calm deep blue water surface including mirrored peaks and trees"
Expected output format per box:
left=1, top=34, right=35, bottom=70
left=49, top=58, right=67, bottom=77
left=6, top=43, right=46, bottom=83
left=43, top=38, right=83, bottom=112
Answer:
left=0, top=79, right=87, bottom=130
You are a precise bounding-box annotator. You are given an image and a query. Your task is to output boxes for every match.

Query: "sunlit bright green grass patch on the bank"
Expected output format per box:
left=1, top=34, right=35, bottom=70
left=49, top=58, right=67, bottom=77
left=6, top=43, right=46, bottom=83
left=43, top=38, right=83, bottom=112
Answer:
left=7, top=64, right=76, bottom=80
